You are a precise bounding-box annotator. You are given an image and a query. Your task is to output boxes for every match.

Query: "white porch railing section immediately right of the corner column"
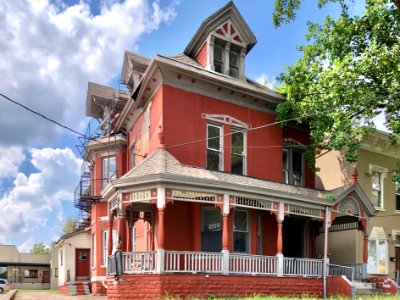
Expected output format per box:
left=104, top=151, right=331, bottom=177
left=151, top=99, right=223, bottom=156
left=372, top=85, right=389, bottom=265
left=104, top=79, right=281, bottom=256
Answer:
left=164, top=250, right=222, bottom=273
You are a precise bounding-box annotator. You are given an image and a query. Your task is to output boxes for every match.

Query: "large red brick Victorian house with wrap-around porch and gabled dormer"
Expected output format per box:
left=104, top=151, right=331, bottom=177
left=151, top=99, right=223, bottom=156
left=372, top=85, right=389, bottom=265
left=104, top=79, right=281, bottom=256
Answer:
left=76, top=2, right=396, bottom=299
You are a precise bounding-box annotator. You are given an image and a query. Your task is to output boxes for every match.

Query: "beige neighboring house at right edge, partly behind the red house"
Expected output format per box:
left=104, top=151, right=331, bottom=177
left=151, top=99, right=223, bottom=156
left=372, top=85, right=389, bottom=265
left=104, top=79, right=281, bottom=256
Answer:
left=316, top=131, right=400, bottom=279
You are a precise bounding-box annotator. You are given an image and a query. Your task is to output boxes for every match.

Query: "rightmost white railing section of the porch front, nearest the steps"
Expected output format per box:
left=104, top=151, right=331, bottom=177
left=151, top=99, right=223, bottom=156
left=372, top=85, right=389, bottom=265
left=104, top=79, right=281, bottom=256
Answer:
left=283, top=257, right=324, bottom=277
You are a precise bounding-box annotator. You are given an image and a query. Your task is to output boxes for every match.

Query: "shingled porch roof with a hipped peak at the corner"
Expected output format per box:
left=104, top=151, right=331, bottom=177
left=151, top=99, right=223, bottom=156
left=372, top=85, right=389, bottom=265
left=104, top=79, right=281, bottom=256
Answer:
left=105, top=148, right=348, bottom=206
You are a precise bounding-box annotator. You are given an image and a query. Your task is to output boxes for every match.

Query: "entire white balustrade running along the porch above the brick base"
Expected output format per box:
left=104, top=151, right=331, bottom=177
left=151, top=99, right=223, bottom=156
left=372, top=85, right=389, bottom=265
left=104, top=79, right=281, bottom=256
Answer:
left=108, top=250, right=323, bottom=277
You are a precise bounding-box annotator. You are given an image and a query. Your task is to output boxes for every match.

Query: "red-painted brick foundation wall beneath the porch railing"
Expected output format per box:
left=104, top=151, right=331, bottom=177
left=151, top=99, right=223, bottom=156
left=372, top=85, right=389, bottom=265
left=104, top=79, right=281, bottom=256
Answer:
left=107, top=274, right=323, bottom=300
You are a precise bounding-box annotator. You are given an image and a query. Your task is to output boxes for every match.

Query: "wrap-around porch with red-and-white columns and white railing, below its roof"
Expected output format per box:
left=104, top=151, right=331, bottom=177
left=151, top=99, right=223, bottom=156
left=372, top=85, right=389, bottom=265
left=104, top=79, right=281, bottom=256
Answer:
left=107, top=187, right=368, bottom=280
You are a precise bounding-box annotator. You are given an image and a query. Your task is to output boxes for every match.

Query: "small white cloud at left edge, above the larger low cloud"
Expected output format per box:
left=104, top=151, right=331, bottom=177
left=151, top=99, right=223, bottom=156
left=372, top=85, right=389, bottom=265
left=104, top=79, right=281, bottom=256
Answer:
left=0, top=145, right=25, bottom=179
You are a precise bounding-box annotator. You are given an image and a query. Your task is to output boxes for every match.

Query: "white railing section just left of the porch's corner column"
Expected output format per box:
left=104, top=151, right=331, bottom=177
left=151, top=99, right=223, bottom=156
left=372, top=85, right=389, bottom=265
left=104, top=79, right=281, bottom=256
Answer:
left=122, top=251, right=157, bottom=274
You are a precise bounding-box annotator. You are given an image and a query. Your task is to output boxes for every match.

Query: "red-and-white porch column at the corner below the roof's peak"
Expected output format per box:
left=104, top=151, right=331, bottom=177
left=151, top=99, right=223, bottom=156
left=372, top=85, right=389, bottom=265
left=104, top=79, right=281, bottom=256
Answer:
left=156, top=187, right=166, bottom=273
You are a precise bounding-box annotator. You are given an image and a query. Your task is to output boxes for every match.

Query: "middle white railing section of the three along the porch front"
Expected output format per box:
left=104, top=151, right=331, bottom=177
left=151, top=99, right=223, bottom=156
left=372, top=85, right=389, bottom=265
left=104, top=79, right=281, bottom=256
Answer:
left=229, top=253, right=277, bottom=275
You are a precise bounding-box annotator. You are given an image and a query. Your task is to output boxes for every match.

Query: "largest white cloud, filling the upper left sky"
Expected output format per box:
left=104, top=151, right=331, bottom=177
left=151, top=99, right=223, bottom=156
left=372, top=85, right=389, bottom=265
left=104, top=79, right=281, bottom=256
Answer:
left=0, top=0, right=178, bottom=147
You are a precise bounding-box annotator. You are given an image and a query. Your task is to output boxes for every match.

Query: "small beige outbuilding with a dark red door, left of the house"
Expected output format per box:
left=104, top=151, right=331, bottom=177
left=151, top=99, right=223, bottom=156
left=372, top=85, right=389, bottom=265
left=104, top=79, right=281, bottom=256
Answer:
left=52, top=228, right=91, bottom=292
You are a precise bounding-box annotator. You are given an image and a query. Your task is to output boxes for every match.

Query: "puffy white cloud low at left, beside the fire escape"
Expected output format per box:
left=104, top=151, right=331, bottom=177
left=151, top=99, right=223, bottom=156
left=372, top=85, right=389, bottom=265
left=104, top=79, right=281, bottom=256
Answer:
left=0, top=148, right=82, bottom=240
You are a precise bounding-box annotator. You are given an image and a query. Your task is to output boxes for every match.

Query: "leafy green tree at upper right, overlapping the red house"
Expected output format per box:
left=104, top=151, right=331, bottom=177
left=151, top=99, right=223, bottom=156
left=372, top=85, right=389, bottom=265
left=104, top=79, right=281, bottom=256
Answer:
left=277, top=0, right=400, bottom=178
